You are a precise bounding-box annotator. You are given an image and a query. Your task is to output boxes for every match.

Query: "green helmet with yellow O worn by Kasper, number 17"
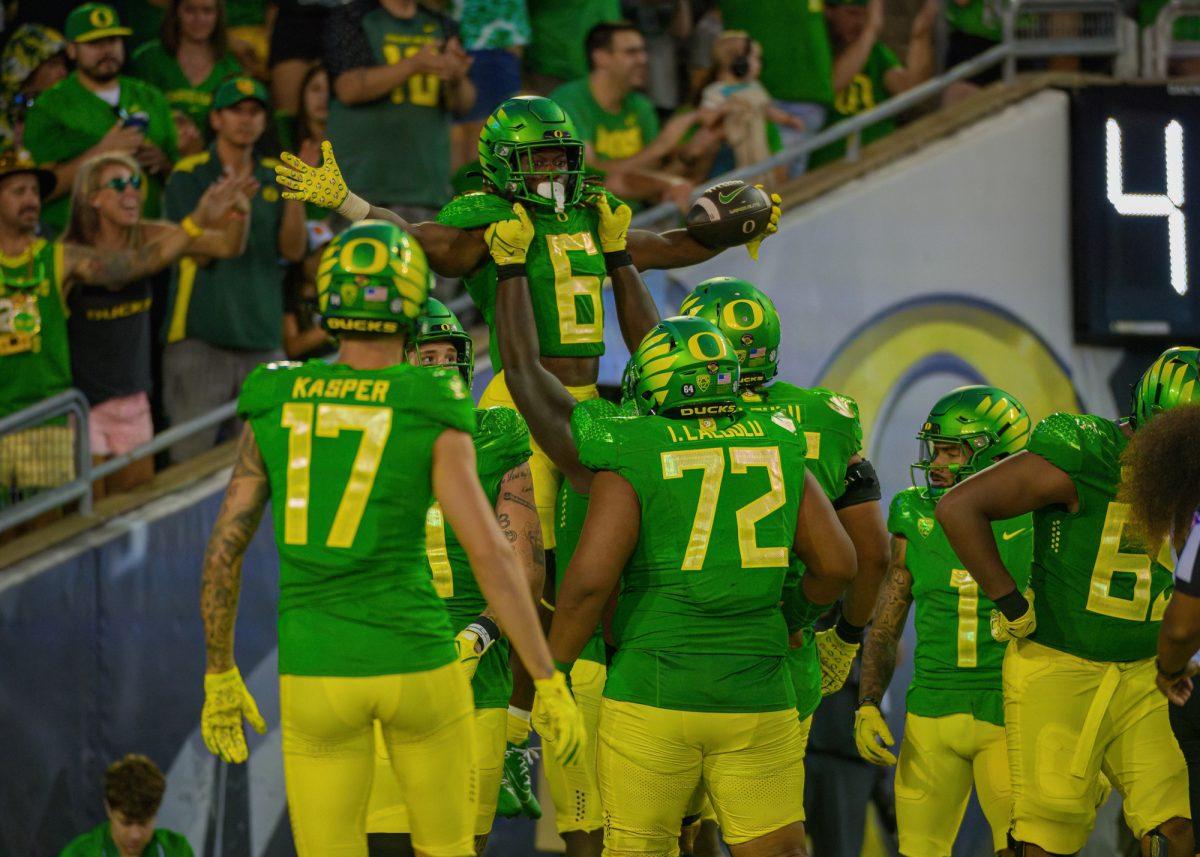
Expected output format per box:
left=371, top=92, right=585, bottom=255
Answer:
left=317, top=220, right=433, bottom=336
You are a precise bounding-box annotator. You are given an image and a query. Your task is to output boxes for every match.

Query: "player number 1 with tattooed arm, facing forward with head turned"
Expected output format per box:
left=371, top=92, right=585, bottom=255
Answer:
left=854, top=385, right=1033, bottom=857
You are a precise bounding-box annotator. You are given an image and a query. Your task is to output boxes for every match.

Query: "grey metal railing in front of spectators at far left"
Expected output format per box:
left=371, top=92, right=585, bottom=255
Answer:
left=0, top=389, right=238, bottom=533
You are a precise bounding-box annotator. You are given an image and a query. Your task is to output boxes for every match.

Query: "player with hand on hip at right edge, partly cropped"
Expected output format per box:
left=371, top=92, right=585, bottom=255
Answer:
left=936, top=348, right=1200, bottom=857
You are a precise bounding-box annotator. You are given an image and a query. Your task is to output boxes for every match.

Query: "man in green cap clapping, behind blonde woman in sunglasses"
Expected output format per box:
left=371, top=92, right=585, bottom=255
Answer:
left=162, top=77, right=308, bottom=461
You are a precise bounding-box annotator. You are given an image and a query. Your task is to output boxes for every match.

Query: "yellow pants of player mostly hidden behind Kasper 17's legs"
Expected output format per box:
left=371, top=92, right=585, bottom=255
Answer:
left=367, top=708, right=506, bottom=837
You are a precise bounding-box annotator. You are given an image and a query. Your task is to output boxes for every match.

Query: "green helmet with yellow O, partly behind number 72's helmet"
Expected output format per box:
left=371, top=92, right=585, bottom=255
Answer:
left=679, top=277, right=779, bottom=389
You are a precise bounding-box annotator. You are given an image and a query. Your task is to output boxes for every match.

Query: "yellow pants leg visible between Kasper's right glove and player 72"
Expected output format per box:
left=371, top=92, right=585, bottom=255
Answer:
left=541, top=660, right=608, bottom=834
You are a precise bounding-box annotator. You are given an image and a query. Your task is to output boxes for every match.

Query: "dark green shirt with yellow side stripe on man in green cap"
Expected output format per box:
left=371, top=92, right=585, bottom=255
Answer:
left=163, top=144, right=287, bottom=352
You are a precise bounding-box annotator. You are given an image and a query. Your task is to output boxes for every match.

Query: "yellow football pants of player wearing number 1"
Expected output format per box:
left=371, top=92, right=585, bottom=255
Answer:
left=895, top=713, right=1013, bottom=857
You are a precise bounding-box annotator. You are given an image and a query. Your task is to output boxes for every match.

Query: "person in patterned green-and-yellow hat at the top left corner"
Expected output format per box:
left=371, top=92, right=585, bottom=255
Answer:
left=0, top=24, right=67, bottom=146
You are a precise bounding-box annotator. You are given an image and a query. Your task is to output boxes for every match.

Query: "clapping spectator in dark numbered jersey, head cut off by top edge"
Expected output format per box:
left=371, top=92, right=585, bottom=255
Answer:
left=325, top=0, right=475, bottom=223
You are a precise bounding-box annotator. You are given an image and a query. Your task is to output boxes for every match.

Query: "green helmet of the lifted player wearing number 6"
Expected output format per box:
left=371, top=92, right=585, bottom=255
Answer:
left=479, top=95, right=583, bottom=211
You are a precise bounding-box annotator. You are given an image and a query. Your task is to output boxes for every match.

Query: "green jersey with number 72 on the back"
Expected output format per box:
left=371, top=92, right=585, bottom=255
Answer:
left=575, top=412, right=804, bottom=712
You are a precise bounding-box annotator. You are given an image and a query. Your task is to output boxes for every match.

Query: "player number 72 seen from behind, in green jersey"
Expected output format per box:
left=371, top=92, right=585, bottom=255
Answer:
left=551, top=316, right=854, bottom=857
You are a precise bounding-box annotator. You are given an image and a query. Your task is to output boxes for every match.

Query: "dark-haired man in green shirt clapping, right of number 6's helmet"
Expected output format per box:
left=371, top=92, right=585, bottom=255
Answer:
left=550, top=22, right=720, bottom=210
